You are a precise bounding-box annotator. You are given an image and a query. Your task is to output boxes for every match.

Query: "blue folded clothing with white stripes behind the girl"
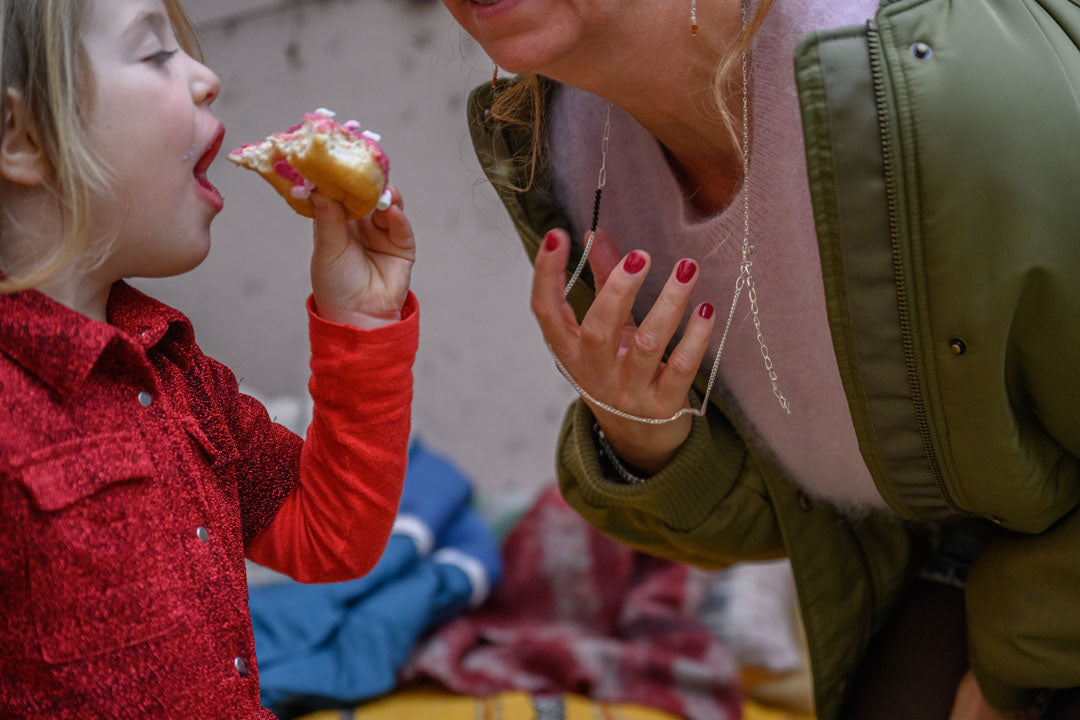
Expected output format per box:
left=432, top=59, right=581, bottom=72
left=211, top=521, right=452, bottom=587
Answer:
left=248, top=441, right=501, bottom=718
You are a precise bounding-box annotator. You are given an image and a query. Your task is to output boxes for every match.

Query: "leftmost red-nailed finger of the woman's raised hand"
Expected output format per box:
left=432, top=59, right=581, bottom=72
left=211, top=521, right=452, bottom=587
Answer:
left=531, top=230, right=578, bottom=363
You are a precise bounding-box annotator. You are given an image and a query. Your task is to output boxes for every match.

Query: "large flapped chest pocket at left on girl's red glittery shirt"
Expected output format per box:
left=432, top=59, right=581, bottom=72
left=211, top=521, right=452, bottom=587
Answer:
left=15, top=433, right=190, bottom=663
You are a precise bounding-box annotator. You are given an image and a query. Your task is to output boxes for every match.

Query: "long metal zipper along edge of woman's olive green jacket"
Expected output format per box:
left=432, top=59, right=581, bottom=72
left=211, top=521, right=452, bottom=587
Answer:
left=866, top=19, right=959, bottom=511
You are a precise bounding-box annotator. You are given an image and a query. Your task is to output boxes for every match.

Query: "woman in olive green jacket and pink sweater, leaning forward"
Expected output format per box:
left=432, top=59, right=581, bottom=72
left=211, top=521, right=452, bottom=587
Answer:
left=444, top=0, right=1080, bottom=720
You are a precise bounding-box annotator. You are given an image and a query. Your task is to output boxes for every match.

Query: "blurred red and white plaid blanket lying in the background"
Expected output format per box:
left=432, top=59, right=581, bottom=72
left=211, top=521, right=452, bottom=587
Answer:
left=404, top=488, right=740, bottom=720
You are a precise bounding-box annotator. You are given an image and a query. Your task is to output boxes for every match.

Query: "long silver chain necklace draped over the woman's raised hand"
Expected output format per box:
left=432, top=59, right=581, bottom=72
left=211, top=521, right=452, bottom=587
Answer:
left=548, top=14, right=792, bottom=425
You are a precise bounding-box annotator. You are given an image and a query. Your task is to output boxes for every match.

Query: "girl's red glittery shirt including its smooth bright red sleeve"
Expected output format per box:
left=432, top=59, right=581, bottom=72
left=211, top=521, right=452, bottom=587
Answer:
left=0, top=283, right=418, bottom=720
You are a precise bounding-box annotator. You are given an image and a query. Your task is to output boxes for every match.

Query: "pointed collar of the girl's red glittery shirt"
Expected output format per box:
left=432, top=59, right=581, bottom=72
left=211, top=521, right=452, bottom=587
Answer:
left=0, top=282, right=193, bottom=397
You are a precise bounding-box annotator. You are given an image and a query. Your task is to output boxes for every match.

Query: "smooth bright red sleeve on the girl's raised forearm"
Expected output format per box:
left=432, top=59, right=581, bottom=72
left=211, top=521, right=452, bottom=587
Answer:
left=246, top=294, right=419, bottom=583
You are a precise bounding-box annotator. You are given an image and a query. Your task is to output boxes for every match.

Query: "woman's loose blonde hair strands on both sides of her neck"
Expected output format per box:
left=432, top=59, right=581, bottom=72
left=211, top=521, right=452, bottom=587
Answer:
left=489, top=0, right=773, bottom=192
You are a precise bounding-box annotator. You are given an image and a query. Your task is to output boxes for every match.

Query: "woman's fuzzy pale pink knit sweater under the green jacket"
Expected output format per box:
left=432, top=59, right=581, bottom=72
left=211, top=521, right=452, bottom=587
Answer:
left=551, top=0, right=885, bottom=514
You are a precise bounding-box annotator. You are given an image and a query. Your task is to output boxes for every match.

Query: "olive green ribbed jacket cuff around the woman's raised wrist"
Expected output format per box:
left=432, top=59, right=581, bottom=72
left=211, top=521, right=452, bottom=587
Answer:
left=561, top=390, right=745, bottom=531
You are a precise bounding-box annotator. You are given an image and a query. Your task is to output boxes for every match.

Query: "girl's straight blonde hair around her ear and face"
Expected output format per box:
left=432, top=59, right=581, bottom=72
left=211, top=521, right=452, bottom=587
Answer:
left=0, top=0, right=202, bottom=293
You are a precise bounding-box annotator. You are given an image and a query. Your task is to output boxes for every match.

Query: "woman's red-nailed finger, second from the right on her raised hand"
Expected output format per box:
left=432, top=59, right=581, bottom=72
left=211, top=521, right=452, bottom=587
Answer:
left=624, top=259, right=698, bottom=383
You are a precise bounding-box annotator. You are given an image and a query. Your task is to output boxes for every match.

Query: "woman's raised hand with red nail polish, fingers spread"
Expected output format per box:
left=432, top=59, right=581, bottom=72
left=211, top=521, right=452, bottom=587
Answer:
left=532, top=230, right=715, bottom=474
